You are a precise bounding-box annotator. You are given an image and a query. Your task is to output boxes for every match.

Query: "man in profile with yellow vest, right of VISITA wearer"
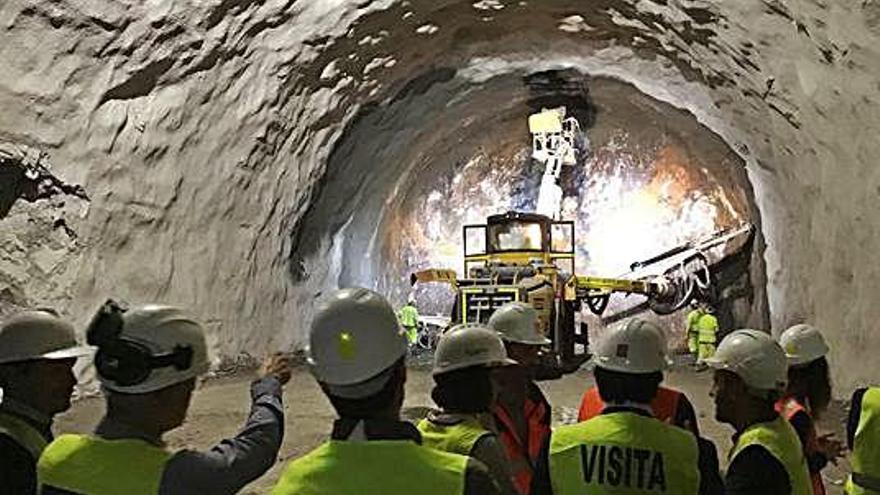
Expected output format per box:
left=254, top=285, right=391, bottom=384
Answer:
left=706, top=329, right=813, bottom=495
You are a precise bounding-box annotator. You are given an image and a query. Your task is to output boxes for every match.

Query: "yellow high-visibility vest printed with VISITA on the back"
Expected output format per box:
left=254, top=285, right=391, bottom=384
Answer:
left=550, top=412, right=700, bottom=495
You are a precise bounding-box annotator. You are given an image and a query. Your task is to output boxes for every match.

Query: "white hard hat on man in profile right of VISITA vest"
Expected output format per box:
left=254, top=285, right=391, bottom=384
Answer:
left=705, top=329, right=788, bottom=398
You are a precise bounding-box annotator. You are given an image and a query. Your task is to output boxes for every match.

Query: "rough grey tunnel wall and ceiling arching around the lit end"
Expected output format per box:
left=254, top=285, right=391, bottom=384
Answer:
left=0, top=0, right=880, bottom=392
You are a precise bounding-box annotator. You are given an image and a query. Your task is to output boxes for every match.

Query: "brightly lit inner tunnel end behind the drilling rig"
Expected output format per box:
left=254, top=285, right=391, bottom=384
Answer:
left=290, top=69, right=764, bottom=325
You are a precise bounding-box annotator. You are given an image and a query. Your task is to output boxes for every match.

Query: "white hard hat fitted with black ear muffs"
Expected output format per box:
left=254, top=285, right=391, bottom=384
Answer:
left=93, top=305, right=210, bottom=394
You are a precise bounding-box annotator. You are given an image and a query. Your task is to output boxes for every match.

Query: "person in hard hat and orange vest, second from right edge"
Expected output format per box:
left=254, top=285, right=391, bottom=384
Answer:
left=776, top=324, right=843, bottom=495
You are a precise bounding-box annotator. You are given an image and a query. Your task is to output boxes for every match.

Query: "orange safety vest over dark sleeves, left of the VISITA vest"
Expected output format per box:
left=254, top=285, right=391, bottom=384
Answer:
left=493, top=390, right=550, bottom=495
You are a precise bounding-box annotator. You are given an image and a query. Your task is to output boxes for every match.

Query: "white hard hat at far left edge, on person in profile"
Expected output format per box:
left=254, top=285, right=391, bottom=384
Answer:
left=0, top=310, right=92, bottom=364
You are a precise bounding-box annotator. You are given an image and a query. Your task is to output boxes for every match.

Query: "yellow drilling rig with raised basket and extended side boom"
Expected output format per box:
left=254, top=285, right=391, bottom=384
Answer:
left=410, top=108, right=753, bottom=378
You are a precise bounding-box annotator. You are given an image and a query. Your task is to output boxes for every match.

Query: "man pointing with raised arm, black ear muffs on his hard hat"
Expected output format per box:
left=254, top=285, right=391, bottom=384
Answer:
left=37, top=301, right=290, bottom=495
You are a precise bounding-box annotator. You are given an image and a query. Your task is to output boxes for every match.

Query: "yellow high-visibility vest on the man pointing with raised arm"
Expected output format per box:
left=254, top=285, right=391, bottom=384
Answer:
left=37, top=435, right=171, bottom=495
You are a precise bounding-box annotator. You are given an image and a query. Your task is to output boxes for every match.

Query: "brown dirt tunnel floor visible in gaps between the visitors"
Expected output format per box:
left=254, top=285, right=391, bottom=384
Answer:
left=55, top=366, right=849, bottom=495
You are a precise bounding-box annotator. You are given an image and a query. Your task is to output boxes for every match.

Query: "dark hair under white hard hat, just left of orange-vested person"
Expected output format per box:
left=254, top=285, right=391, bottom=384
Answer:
left=431, top=366, right=494, bottom=414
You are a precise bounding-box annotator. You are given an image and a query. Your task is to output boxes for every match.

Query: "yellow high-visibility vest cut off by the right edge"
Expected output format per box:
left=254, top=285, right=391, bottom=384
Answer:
left=846, top=387, right=880, bottom=495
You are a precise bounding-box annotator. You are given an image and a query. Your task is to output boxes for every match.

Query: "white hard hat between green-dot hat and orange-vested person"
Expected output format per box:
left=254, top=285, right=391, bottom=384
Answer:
left=434, top=324, right=516, bottom=375
